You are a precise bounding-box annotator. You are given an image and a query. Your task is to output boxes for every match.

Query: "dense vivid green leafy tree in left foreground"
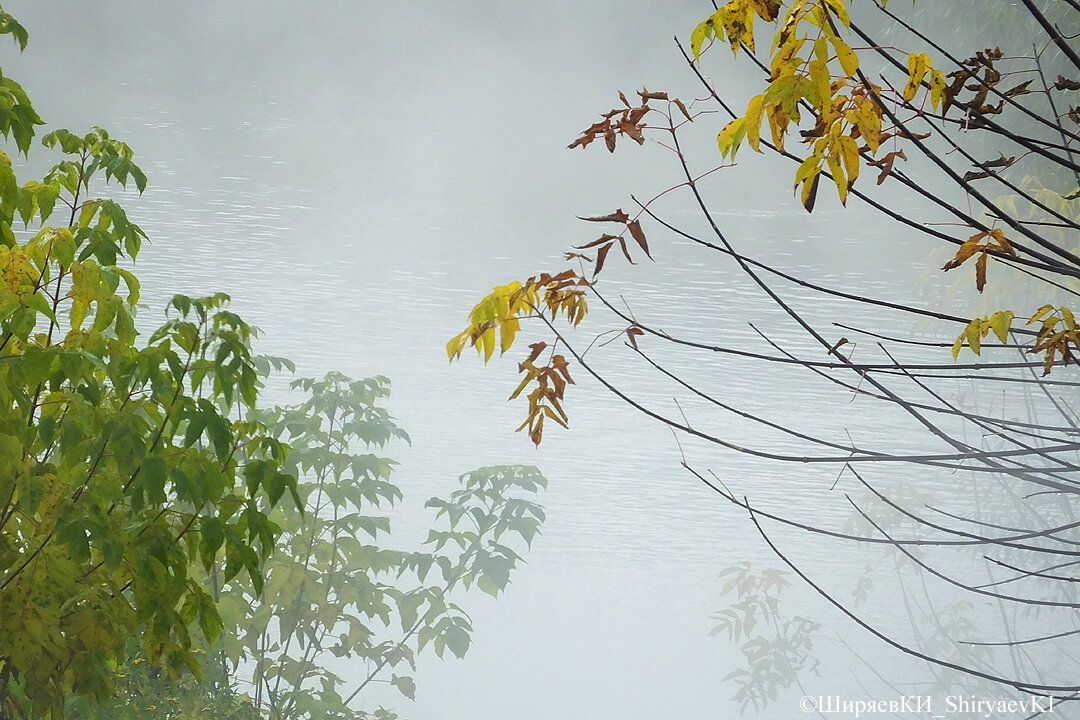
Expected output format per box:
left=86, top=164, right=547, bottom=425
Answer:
left=0, top=11, right=295, bottom=717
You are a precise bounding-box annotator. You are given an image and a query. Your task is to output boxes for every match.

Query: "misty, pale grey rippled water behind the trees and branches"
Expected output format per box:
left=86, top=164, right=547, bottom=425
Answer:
left=4, top=2, right=1075, bottom=720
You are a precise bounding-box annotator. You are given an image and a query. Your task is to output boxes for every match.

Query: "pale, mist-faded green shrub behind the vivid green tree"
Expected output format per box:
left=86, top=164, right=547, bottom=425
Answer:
left=63, top=373, right=546, bottom=720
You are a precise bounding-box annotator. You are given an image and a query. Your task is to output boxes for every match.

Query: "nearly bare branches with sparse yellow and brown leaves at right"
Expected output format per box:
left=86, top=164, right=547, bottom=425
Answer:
left=447, top=0, right=1080, bottom=697
